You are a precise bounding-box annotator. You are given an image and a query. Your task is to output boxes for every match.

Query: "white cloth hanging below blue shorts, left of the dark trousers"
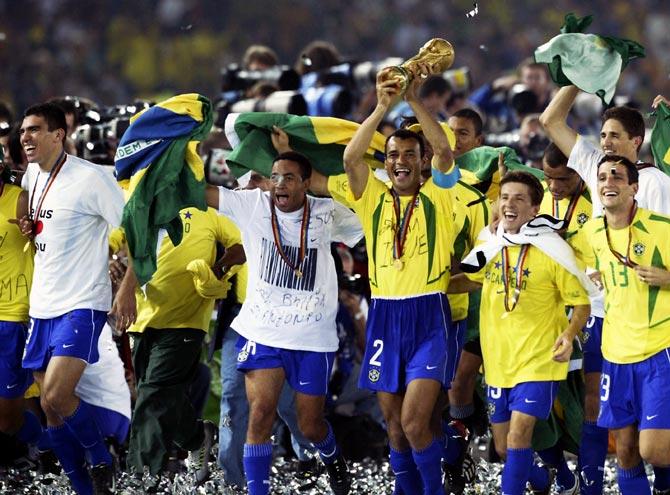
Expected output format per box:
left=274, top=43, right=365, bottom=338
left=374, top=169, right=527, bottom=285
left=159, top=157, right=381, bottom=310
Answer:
left=74, top=323, right=130, bottom=419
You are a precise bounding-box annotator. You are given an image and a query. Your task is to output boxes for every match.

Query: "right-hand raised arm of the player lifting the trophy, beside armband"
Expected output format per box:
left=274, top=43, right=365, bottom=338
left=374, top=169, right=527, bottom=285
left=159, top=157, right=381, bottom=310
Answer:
left=405, top=66, right=454, bottom=173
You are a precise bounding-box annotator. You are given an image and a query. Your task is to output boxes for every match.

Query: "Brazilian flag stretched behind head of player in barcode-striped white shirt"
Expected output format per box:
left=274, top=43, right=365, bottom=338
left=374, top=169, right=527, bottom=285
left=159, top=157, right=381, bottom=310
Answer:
left=225, top=112, right=386, bottom=178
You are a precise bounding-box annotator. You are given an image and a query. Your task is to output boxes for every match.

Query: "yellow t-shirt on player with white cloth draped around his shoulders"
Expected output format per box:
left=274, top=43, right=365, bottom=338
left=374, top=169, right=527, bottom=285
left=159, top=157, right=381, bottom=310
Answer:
left=467, top=246, right=589, bottom=387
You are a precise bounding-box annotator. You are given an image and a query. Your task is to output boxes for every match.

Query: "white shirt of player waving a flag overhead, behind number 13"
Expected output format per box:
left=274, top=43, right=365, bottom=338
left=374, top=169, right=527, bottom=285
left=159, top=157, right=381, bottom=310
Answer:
left=568, top=136, right=670, bottom=218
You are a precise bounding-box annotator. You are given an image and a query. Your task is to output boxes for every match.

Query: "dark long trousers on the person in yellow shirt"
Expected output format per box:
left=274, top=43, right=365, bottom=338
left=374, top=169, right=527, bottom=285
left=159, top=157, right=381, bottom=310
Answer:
left=127, top=328, right=205, bottom=474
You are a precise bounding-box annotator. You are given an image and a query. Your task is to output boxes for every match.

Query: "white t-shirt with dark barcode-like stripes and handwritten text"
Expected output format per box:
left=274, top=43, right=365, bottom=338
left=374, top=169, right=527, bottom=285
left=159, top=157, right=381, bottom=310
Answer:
left=219, top=188, right=363, bottom=352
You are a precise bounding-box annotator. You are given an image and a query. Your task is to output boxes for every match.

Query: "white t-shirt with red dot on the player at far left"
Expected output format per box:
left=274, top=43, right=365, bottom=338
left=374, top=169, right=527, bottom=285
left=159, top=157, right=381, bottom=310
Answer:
left=22, top=155, right=124, bottom=318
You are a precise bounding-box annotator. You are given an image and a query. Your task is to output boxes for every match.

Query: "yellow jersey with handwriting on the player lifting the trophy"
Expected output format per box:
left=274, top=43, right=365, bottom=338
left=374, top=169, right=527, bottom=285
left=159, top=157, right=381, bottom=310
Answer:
left=348, top=170, right=456, bottom=298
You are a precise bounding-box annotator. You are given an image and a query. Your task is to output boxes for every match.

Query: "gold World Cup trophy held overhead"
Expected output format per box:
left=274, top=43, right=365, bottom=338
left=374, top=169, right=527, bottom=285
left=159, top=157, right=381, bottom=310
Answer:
left=384, top=38, right=454, bottom=93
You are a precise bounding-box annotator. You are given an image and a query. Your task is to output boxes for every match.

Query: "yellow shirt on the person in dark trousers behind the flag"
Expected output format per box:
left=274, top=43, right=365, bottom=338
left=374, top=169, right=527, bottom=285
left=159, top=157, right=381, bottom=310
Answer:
left=128, top=208, right=241, bottom=332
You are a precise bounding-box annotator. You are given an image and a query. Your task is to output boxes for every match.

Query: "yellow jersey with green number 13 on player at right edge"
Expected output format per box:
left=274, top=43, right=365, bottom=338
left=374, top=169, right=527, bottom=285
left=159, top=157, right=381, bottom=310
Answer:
left=571, top=208, right=670, bottom=363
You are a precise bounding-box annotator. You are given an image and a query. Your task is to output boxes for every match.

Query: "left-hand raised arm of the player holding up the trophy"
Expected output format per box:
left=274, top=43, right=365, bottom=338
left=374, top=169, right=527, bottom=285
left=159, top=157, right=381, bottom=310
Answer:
left=343, top=69, right=399, bottom=199
